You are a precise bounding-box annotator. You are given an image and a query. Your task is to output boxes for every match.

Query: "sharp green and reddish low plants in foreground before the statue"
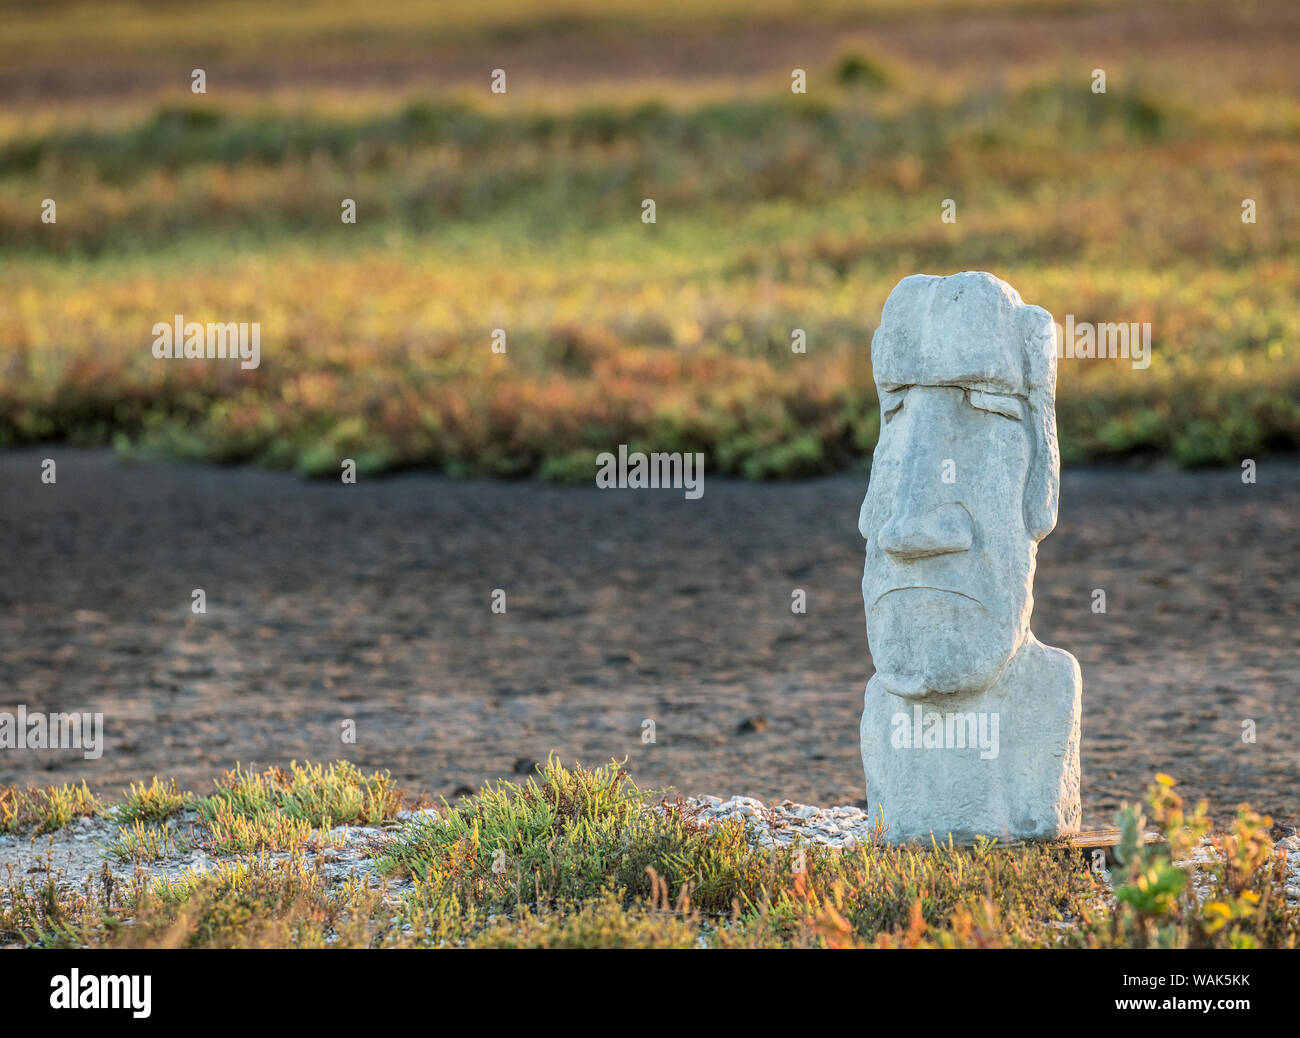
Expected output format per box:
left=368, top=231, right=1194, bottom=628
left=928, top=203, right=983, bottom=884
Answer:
left=0, top=758, right=1300, bottom=948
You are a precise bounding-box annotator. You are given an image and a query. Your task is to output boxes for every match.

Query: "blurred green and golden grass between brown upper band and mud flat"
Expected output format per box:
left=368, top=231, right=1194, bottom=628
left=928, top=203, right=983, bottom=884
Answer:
left=0, top=51, right=1300, bottom=481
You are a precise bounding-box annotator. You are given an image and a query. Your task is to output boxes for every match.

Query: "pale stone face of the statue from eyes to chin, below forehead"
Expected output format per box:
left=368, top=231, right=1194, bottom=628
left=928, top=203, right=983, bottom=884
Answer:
left=859, top=385, right=1037, bottom=699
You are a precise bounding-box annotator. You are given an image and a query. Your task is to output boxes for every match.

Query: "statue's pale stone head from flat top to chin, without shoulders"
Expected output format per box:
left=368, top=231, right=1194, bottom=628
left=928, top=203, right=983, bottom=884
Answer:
left=858, top=274, right=1057, bottom=699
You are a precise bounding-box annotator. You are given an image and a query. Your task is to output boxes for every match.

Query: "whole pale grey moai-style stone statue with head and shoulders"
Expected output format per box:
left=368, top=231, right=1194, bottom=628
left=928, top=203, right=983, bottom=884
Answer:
left=858, top=271, right=1083, bottom=843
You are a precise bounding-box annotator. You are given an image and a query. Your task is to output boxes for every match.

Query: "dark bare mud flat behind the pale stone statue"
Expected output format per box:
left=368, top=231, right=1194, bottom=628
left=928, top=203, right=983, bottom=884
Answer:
left=0, top=449, right=1300, bottom=827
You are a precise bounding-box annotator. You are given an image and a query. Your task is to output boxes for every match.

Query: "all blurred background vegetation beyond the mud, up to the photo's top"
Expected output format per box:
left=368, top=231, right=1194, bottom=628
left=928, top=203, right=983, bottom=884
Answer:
left=0, top=0, right=1300, bottom=481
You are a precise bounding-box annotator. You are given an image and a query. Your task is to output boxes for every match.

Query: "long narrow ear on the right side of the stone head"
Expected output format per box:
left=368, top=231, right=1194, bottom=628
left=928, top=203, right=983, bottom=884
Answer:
left=1021, top=307, right=1061, bottom=541
